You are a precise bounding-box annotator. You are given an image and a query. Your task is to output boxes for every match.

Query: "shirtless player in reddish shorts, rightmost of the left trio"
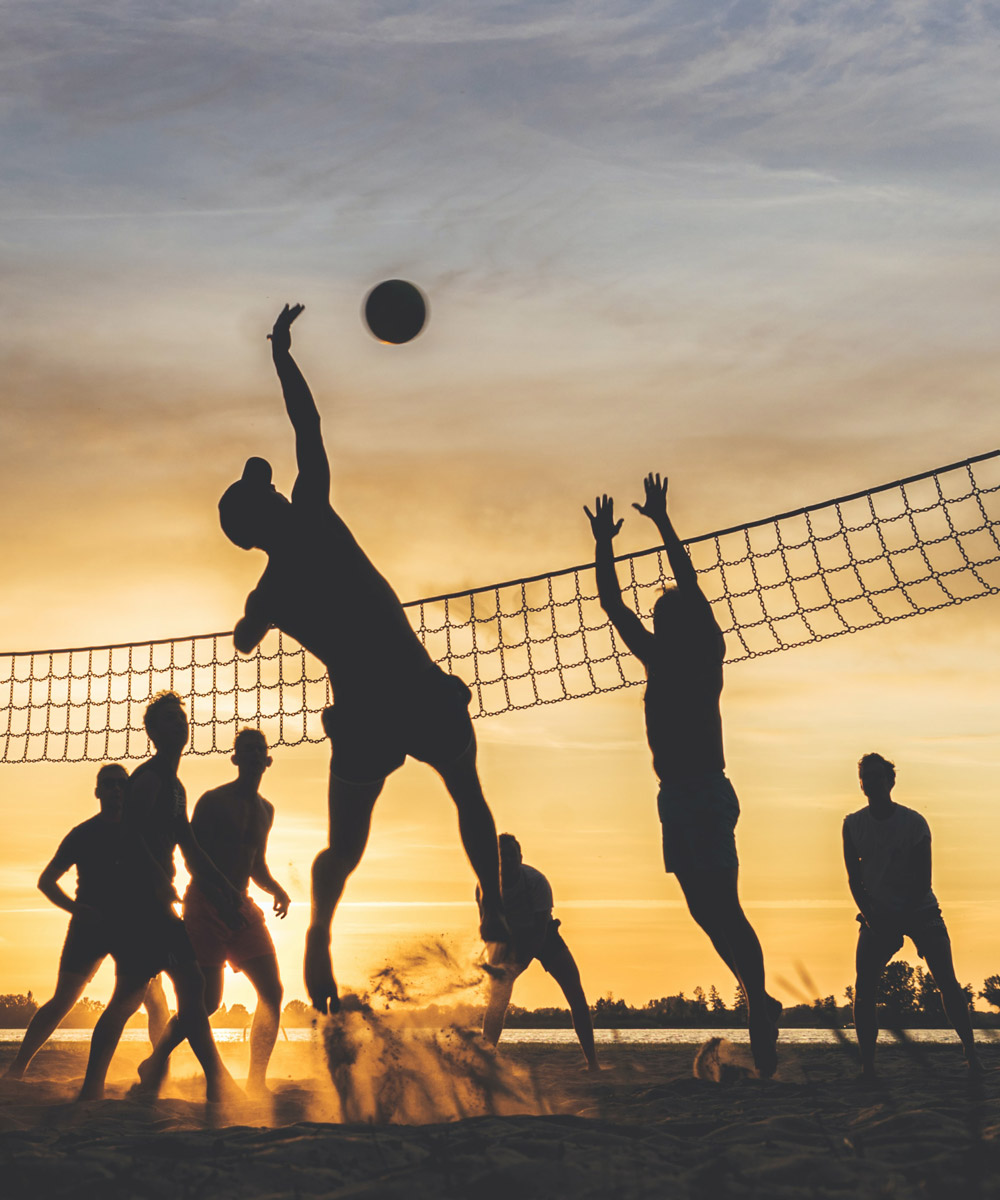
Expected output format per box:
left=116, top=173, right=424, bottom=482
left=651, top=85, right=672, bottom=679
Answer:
left=134, top=730, right=291, bottom=1094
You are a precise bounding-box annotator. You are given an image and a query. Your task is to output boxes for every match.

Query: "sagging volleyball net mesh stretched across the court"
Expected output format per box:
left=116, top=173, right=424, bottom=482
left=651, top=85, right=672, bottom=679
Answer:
left=0, top=450, right=1000, bottom=762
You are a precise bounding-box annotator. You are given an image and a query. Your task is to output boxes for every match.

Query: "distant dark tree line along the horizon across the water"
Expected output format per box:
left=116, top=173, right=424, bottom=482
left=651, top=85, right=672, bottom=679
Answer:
left=7, top=960, right=1000, bottom=1030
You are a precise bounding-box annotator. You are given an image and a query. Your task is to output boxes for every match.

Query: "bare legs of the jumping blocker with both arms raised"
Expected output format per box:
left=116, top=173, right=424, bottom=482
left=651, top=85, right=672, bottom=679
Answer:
left=677, top=869, right=782, bottom=1078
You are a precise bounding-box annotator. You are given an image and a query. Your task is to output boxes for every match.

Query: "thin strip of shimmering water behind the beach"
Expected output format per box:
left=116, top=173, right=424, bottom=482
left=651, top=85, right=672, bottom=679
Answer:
left=0, top=1028, right=984, bottom=1046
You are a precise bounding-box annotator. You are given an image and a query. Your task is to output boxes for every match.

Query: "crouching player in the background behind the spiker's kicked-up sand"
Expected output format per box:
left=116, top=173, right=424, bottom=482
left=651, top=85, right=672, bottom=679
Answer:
left=477, top=833, right=599, bottom=1070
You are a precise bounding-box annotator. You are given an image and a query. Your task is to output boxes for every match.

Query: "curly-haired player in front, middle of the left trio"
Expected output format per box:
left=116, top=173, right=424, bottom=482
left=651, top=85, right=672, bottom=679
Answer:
left=80, top=692, right=240, bottom=1100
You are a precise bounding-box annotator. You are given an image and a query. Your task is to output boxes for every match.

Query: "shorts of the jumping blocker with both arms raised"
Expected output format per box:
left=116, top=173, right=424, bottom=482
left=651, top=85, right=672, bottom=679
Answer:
left=657, top=770, right=739, bottom=874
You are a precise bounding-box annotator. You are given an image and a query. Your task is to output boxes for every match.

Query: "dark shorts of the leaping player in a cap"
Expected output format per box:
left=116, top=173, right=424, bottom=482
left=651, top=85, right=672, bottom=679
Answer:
left=323, top=666, right=473, bottom=784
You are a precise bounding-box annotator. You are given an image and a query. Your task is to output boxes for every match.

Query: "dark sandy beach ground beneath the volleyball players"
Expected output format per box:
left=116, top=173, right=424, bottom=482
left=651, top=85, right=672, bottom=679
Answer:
left=0, top=1043, right=1000, bottom=1200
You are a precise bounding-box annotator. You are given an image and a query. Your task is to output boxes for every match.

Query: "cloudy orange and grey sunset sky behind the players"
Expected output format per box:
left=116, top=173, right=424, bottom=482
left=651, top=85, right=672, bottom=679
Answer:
left=0, top=0, right=1000, bottom=1022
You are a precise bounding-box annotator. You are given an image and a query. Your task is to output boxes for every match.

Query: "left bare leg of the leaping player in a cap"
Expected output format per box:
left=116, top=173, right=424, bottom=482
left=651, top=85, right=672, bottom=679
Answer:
left=305, top=772, right=385, bottom=1013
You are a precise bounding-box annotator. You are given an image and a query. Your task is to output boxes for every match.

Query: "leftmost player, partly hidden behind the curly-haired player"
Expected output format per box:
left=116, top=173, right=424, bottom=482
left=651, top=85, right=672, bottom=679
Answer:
left=5, top=762, right=169, bottom=1079
